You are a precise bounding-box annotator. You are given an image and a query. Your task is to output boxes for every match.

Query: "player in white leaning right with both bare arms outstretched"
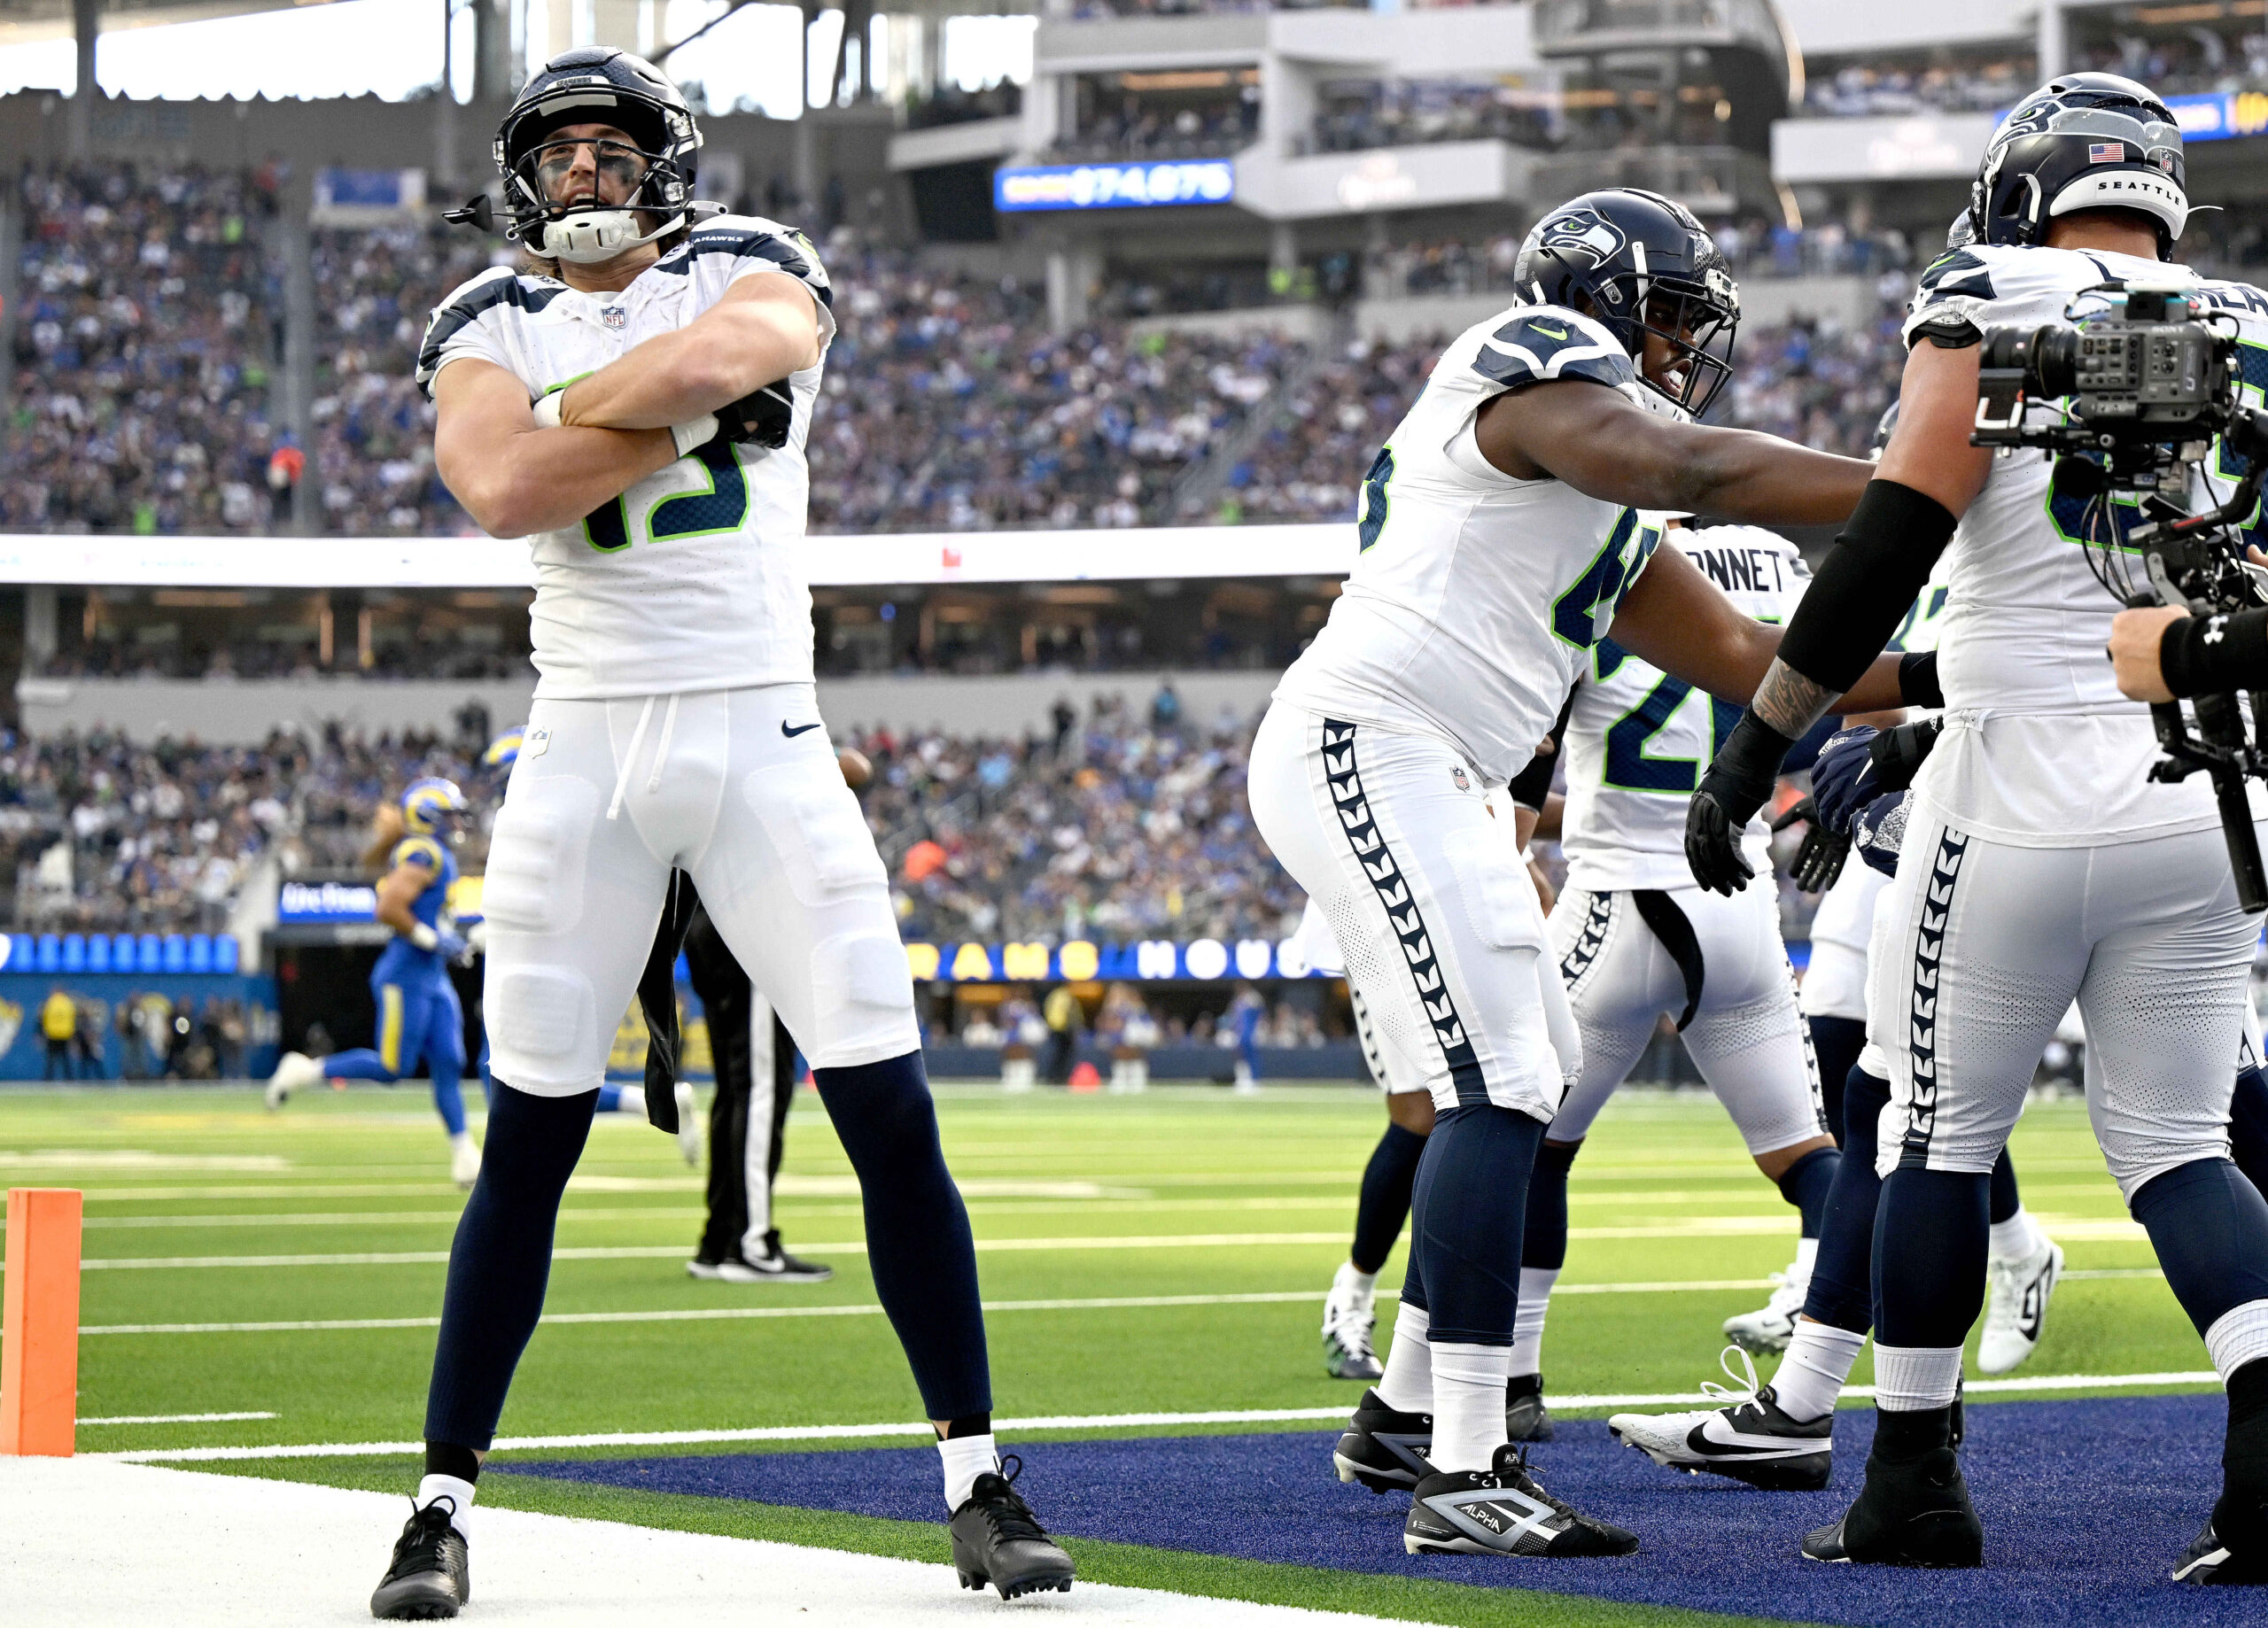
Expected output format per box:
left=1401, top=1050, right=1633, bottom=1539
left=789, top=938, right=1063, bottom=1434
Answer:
left=1250, top=188, right=1932, bottom=1555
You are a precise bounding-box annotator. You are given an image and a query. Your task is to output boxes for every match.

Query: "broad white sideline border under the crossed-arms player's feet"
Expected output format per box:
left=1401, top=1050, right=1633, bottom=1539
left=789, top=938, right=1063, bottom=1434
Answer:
left=0, top=1460, right=1415, bottom=1628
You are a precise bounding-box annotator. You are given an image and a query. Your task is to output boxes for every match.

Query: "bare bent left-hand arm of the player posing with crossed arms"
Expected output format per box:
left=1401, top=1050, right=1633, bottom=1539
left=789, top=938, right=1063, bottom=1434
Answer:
left=433, top=358, right=678, bottom=538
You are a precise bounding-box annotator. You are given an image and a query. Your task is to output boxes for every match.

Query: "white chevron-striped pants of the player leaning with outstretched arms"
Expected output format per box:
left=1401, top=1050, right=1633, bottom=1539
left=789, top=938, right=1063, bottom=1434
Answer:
left=1247, top=701, right=1572, bottom=1122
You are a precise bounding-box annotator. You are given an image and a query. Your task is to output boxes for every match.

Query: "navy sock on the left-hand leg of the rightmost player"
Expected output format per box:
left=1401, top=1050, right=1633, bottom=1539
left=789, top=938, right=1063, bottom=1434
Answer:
left=1874, top=1167, right=1992, bottom=1352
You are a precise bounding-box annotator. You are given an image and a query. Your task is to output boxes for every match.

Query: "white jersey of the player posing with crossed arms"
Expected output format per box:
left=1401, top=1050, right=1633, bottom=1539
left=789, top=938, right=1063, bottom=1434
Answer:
left=417, top=215, right=835, bottom=701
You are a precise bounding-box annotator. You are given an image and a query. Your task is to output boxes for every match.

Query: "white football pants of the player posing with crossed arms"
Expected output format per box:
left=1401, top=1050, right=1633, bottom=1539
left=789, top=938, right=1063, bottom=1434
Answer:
left=483, top=685, right=920, bottom=1102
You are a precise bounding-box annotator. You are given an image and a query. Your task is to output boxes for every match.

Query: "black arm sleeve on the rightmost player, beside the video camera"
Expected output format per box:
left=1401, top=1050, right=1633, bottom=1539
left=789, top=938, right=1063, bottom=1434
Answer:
left=1781, top=477, right=1955, bottom=694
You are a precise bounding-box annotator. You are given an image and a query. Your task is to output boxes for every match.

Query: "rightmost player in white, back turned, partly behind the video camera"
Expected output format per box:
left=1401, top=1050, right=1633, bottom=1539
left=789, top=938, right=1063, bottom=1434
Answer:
left=1688, top=73, right=2268, bottom=1583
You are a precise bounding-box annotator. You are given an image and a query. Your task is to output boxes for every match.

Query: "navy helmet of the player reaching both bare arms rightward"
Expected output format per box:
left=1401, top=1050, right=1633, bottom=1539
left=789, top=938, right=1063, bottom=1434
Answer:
left=1513, top=186, right=1740, bottom=417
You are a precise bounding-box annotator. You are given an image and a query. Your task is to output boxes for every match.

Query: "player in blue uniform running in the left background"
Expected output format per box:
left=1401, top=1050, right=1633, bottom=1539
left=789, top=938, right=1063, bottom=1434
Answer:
left=268, top=780, right=481, bottom=1188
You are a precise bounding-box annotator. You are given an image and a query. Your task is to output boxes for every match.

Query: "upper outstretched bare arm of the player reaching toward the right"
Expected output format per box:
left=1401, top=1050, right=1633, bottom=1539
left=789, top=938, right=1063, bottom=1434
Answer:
left=1474, top=381, right=1874, bottom=526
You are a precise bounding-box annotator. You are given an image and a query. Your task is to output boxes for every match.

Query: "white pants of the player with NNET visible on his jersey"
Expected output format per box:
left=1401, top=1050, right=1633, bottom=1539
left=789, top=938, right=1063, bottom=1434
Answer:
left=1549, top=887, right=1826, bottom=1154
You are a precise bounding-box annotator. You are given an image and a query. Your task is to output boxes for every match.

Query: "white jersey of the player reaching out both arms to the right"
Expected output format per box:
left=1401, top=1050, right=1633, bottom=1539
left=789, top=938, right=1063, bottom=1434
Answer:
left=1277, top=306, right=1676, bottom=785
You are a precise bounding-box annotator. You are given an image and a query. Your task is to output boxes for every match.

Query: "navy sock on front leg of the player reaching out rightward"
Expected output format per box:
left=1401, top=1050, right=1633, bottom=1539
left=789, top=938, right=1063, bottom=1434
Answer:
left=1410, top=1105, right=1544, bottom=1347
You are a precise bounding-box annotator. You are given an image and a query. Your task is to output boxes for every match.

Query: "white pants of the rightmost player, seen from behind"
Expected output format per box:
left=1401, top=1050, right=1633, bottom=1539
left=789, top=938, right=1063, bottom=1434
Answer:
left=1868, top=805, right=2259, bottom=1199
